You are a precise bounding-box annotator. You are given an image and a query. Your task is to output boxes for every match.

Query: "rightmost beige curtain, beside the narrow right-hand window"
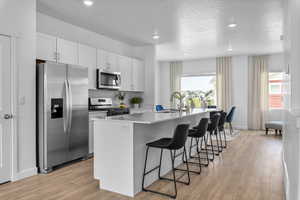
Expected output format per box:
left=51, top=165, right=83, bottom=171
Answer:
left=248, top=56, right=269, bottom=130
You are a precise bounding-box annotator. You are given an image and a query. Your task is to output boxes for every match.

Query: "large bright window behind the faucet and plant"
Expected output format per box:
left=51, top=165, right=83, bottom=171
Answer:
left=181, top=74, right=216, bottom=108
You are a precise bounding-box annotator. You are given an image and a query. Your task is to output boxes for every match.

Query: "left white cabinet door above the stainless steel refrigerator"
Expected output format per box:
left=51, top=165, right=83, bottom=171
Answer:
left=36, top=33, right=56, bottom=62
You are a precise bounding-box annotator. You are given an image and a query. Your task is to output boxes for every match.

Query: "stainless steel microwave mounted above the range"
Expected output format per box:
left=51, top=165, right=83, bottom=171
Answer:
left=97, top=69, right=121, bottom=90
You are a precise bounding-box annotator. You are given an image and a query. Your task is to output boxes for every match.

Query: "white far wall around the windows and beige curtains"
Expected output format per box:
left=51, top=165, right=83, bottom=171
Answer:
left=158, top=53, right=284, bottom=129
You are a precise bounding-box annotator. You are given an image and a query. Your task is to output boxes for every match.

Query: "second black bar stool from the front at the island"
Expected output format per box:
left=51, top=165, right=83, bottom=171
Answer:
left=184, top=118, right=209, bottom=174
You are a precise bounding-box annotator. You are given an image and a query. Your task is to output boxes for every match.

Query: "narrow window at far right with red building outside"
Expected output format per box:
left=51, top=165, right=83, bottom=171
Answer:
left=269, top=72, right=283, bottom=109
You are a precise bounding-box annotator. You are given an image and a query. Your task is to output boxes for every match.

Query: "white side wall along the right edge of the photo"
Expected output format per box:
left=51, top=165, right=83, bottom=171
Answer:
left=283, top=0, right=300, bottom=200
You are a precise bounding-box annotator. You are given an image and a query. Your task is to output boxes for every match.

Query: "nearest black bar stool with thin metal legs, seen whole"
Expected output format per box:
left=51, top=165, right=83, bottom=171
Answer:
left=142, top=124, right=190, bottom=198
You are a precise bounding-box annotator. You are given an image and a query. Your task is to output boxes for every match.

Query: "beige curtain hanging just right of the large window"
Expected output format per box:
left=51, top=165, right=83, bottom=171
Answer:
left=216, top=57, right=233, bottom=111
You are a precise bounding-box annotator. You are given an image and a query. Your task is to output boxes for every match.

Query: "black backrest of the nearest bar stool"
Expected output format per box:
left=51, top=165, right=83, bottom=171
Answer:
left=169, top=124, right=190, bottom=150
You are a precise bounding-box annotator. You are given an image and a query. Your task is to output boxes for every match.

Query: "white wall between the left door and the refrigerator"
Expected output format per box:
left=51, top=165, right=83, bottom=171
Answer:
left=0, top=0, right=36, bottom=180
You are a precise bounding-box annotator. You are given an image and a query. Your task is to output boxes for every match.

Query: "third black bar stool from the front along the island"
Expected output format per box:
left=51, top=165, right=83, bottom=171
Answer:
left=206, top=113, right=221, bottom=161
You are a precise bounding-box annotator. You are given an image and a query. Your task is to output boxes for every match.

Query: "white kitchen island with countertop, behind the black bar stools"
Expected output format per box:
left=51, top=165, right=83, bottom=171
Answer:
left=93, top=109, right=209, bottom=197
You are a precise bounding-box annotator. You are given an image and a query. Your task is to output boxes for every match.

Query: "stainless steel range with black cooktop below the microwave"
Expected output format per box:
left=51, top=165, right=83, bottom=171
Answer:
left=89, top=98, right=130, bottom=116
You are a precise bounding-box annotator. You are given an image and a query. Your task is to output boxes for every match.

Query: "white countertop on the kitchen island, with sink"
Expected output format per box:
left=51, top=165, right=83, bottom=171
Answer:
left=93, top=109, right=212, bottom=124
